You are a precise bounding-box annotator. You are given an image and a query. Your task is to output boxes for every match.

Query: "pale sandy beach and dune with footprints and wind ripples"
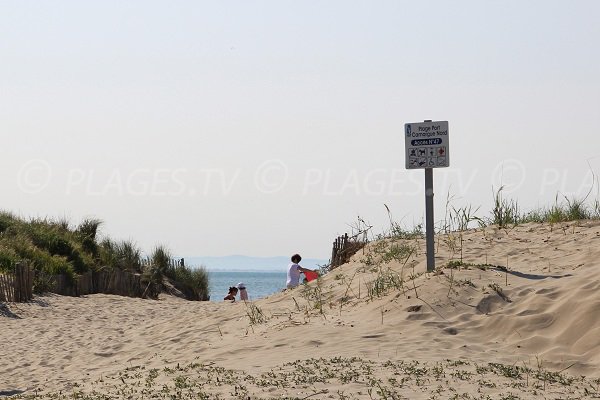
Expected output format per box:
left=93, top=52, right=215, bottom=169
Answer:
left=0, top=221, right=600, bottom=399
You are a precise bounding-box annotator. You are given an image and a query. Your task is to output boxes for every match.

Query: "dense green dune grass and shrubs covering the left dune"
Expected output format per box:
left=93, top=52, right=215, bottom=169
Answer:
left=0, top=211, right=209, bottom=300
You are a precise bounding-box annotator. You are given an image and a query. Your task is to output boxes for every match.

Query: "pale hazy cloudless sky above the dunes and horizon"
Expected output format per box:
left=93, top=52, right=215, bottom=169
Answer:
left=0, top=0, right=600, bottom=258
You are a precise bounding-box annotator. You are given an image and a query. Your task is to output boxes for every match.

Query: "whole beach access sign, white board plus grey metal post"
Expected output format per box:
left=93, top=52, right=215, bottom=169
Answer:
left=404, top=120, right=450, bottom=272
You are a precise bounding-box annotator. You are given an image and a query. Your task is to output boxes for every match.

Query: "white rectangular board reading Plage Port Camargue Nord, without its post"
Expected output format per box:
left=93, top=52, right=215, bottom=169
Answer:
left=404, top=121, right=450, bottom=169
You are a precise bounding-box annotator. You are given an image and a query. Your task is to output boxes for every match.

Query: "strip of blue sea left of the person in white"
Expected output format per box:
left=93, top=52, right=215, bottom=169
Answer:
left=208, top=270, right=287, bottom=301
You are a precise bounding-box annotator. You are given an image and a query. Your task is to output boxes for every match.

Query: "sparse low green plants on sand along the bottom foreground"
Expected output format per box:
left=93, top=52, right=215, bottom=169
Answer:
left=14, top=357, right=600, bottom=400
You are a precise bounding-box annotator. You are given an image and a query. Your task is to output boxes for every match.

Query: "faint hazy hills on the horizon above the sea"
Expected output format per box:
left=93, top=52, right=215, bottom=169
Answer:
left=185, top=255, right=328, bottom=272
